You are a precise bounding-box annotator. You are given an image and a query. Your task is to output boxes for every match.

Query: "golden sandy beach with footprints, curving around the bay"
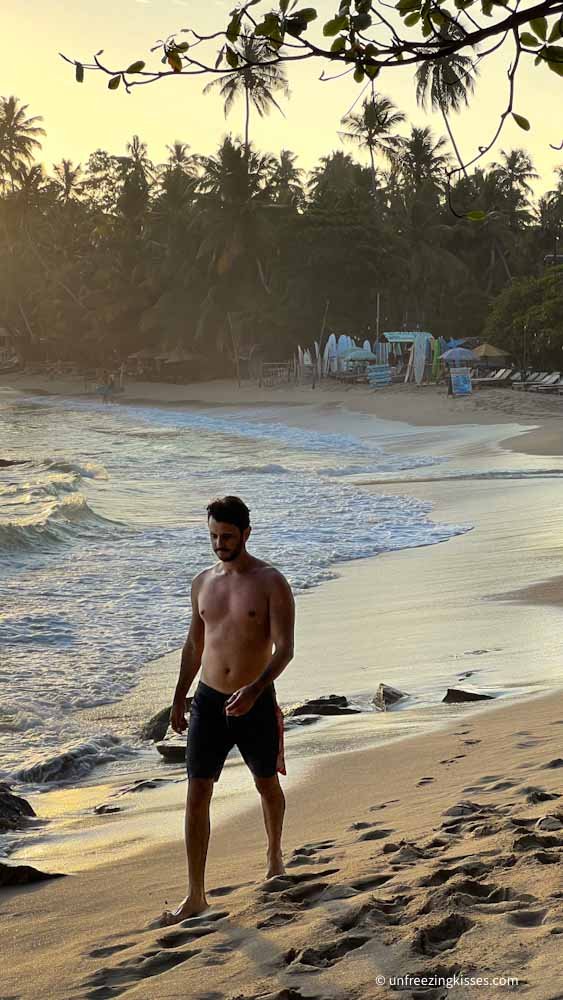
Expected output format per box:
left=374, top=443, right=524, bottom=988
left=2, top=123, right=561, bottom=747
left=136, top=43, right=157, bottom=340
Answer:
left=0, top=375, right=563, bottom=1000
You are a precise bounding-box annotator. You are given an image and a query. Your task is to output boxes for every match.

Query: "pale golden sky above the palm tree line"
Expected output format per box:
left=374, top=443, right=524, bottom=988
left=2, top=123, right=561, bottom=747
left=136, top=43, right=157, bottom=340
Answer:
left=0, top=0, right=563, bottom=192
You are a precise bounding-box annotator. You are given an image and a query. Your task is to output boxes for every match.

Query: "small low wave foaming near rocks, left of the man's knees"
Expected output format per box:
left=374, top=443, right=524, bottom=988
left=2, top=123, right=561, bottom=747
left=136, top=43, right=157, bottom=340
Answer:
left=13, top=734, right=136, bottom=785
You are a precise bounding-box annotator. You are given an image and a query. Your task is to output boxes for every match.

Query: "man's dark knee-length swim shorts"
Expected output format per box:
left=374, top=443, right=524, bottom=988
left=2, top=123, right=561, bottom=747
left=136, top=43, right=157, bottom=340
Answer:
left=186, top=681, right=286, bottom=781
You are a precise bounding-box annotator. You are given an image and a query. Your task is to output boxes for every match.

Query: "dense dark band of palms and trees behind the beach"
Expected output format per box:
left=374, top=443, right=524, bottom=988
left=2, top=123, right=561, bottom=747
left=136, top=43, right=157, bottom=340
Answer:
left=0, top=91, right=563, bottom=370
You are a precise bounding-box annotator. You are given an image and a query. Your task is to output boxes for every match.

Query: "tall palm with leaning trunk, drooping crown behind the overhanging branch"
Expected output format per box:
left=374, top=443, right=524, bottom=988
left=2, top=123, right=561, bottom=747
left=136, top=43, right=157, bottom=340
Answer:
left=415, top=31, right=478, bottom=177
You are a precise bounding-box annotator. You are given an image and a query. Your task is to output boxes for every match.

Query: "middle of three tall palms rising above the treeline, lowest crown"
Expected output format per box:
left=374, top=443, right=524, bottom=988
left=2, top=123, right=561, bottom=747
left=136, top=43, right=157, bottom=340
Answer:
left=338, top=94, right=405, bottom=195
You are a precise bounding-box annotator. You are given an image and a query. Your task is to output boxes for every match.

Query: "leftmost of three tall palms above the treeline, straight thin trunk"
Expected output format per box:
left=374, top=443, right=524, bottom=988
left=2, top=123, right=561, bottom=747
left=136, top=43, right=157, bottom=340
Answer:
left=203, top=37, right=289, bottom=156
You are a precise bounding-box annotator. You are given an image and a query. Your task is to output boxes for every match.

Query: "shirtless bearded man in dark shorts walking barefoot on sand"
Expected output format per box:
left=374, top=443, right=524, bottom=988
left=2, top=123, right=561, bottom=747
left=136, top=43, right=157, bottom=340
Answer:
left=162, top=496, right=295, bottom=925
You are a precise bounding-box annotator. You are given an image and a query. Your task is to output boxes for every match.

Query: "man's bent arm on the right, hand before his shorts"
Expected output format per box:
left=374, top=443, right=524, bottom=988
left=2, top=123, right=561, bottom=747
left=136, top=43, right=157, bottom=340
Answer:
left=226, top=573, right=295, bottom=715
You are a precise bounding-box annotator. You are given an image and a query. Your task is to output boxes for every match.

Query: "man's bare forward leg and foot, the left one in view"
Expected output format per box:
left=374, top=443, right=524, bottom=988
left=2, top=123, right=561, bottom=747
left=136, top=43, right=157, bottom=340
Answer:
left=162, top=778, right=217, bottom=926
